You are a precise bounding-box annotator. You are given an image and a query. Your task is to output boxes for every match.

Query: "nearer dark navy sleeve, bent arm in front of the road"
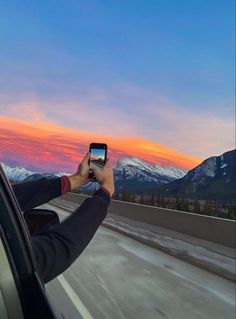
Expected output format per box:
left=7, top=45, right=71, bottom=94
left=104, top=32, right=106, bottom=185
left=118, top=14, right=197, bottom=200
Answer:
left=32, top=189, right=110, bottom=282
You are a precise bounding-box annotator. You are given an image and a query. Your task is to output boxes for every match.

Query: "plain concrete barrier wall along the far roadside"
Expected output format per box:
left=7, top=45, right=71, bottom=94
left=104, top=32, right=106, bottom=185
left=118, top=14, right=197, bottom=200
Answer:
left=60, top=193, right=236, bottom=248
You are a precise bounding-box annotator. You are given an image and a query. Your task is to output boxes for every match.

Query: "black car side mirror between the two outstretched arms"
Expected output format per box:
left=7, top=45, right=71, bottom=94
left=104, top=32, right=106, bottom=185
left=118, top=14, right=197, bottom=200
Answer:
left=24, top=209, right=60, bottom=235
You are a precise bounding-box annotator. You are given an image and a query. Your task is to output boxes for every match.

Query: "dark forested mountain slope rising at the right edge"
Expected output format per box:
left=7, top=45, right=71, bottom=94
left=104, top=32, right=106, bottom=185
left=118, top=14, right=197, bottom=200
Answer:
left=159, top=150, right=236, bottom=200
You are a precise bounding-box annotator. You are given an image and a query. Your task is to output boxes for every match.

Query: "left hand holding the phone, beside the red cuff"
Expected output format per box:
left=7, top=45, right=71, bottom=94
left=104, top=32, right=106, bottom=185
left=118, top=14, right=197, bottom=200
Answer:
left=68, top=152, right=90, bottom=190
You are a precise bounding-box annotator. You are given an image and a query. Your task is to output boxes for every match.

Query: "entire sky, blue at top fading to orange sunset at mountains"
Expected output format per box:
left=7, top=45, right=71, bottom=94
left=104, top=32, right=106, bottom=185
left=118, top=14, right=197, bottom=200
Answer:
left=0, top=0, right=235, bottom=174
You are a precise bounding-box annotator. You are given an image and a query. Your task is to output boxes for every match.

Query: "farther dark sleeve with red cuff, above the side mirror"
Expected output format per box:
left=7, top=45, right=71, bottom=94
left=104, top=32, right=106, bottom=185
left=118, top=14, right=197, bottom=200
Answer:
left=12, top=177, right=61, bottom=211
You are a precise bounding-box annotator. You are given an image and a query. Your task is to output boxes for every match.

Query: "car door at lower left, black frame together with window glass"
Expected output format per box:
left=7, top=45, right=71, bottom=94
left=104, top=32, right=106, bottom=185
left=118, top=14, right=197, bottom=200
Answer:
left=0, top=165, right=61, bottom=319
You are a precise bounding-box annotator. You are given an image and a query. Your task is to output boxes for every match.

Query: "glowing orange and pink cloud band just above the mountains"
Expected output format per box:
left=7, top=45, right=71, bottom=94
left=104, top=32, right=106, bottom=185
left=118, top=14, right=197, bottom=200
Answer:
left=0, top=117, right=201, bottom=172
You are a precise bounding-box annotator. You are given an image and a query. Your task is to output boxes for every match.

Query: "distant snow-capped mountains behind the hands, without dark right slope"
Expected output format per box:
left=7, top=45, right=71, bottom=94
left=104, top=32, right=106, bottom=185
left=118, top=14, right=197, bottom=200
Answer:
left=2, top=157, right=187, bottom=191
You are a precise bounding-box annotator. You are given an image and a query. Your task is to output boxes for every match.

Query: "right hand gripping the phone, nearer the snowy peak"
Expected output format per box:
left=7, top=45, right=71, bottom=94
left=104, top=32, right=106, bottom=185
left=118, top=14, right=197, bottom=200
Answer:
left=92, top=161, right=115, bottom=196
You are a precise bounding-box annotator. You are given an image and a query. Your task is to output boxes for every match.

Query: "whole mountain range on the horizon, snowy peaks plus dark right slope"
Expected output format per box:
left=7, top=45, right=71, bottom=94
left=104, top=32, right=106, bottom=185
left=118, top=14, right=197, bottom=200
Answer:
left=2, top=150, right=236, bottom=200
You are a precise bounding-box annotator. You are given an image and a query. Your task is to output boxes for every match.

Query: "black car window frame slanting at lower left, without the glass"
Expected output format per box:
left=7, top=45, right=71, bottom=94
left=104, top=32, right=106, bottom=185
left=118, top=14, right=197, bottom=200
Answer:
left=0, top=165, right=58, bottom=319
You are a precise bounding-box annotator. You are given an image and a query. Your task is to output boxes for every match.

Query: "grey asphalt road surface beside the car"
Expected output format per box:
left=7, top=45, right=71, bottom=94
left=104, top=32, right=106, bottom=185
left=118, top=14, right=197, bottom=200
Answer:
left=46, top=205, right=235, bottom=319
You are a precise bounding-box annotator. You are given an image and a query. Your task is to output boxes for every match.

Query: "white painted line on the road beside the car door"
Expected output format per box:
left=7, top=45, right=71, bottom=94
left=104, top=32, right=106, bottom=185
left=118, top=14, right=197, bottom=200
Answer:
left=57, top=275, right=93, bottom=319
